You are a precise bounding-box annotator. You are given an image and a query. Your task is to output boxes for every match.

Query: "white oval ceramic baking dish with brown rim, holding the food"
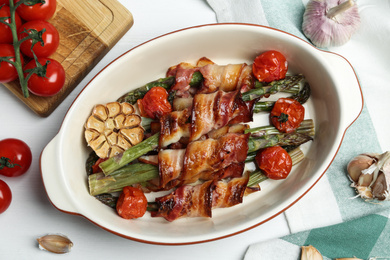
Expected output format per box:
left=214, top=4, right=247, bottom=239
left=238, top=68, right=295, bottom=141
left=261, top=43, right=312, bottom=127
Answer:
left=41, top=24, right=363, bottom=245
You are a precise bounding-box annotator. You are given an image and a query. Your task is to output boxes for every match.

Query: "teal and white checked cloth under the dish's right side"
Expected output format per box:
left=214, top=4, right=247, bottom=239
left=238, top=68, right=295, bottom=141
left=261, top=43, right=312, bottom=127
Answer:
left=207, top=0, right=390, bottom=260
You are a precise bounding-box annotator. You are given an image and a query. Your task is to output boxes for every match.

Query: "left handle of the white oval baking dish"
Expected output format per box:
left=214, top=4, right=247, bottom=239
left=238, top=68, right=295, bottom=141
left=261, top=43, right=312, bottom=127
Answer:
left=40, top=135, right=77, bottom=214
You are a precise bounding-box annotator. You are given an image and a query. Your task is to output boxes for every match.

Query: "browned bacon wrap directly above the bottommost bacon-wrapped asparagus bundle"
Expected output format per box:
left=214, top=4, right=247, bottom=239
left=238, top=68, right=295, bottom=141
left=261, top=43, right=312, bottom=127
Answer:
left=158, top=132, right=249, bottom=189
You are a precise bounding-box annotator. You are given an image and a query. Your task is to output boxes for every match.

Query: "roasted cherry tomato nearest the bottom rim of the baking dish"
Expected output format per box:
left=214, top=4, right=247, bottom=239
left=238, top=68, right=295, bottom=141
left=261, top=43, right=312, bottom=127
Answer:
left=116, top=186, right=148, bottom=219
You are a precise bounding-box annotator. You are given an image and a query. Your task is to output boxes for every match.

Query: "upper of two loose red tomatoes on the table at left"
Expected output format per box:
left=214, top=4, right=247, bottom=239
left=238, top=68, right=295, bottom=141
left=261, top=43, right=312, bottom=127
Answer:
left=0, top=138, right=32, bottom=177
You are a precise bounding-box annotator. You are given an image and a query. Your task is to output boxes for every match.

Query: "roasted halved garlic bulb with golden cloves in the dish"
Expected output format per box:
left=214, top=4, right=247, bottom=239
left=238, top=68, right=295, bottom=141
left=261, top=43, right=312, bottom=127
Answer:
left=85, top=102, right=145, bottom=158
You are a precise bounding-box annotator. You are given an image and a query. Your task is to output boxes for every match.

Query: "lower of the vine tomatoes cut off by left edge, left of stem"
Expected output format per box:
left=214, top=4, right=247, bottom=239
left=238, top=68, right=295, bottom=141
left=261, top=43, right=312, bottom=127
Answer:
left=0, top=44, right=23, bottom=83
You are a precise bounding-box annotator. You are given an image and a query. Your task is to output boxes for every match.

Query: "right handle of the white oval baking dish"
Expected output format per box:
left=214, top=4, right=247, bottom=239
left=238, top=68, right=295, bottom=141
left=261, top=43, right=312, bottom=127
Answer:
left=322, top=51, right=364, bottom=128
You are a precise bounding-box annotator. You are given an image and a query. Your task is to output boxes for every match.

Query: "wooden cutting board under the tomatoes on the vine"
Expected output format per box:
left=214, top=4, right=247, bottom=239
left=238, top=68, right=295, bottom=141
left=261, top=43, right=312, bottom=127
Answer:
left=4, top=0, right=133, bottom=117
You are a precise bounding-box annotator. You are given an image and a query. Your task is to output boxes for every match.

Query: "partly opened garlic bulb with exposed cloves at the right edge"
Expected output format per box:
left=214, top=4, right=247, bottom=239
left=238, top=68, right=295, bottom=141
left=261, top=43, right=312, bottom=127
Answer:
left=347, top=152, right=390, bottom=200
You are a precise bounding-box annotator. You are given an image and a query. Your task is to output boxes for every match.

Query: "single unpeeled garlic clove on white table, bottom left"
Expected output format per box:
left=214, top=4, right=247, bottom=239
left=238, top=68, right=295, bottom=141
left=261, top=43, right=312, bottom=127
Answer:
left=37, top=234, right=73, bottom=254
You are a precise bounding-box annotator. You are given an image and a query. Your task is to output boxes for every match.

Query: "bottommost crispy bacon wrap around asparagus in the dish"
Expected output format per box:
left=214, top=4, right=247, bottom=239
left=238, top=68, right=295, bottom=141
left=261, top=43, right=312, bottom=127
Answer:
left=151, top=173, right=249, bottom=221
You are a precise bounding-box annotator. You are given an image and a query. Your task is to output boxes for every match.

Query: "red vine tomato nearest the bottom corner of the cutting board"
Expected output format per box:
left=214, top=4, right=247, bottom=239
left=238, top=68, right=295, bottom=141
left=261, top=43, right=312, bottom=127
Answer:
left=24, top=58, right=66, bottom=97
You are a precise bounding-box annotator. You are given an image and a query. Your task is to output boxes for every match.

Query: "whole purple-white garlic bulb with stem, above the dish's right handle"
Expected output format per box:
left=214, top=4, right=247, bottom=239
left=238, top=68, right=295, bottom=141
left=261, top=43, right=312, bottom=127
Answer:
left=302, top=0, right=360, bottom=48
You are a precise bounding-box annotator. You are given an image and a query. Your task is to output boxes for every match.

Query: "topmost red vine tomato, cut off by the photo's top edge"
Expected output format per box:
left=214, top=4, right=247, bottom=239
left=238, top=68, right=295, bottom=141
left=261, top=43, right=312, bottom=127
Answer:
left=14, top=0, right=57, bottom=21
